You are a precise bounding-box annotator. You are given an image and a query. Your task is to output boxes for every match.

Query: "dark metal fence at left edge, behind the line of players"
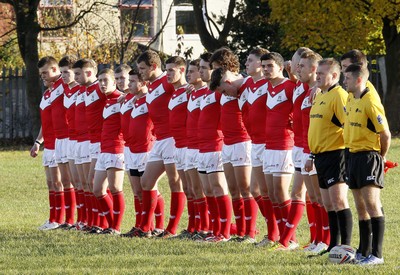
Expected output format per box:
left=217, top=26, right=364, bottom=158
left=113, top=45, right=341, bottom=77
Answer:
left=0, top=68, right=32, bottom=140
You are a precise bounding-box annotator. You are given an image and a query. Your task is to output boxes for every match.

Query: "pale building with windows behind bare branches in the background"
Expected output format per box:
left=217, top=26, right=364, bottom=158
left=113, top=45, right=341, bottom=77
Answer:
left=39, top=0, right=229, bottom=58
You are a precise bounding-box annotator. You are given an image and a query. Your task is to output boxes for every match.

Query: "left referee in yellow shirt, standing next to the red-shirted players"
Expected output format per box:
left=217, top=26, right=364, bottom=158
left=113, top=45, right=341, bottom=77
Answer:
left=308, top=58, right=353, bottom=254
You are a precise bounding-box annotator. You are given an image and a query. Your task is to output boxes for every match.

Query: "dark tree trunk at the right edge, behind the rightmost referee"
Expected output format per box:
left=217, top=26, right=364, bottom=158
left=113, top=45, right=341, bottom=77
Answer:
left=382, top=18, right=400, bottom=134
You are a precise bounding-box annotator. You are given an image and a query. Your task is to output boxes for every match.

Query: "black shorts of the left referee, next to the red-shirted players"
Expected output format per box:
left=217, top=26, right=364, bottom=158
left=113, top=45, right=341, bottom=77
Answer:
left=314, top=149, right=346, bottom=189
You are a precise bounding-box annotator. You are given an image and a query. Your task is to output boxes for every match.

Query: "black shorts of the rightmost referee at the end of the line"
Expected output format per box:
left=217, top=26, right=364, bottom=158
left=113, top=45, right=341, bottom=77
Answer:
left=347, top=151, right=384, bottom=189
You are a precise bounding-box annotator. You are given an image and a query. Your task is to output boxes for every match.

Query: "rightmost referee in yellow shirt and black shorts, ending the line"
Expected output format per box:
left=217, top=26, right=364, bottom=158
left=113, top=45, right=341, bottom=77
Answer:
left=344, top=63, right=391, bottom=265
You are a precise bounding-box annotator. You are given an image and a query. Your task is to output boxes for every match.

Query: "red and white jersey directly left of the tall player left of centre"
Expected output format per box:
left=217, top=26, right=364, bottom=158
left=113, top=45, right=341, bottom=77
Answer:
left=129, top=95, right=155, bottom=153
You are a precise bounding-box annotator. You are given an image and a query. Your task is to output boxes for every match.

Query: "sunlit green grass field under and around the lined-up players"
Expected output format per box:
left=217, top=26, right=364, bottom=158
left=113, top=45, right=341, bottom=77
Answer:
left=0, top=139, right=400, bottom=274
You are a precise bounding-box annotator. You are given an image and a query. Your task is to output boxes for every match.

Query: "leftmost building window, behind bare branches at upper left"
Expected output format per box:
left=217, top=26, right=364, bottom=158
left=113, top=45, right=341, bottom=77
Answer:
left=39, top=0, right=74, bottom=38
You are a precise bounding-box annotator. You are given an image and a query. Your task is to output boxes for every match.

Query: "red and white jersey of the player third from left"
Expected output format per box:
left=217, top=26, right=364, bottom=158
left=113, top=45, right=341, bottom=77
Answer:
left=85, top=81, right=106, bottom=143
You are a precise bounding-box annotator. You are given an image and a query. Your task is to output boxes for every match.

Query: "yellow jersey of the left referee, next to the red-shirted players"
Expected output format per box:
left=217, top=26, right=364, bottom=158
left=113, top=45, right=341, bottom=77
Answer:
left=308, top=85, right=347, bottom=154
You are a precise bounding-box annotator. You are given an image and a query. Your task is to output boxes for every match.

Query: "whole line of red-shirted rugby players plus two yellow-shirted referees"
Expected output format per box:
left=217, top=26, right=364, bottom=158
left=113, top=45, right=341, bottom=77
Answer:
left=30, top=47, right=397, bottom=265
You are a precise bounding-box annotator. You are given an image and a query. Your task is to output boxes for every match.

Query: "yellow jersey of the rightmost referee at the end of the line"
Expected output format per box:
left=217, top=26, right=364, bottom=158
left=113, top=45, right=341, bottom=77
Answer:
left=345, top=89, right=389, bottom=153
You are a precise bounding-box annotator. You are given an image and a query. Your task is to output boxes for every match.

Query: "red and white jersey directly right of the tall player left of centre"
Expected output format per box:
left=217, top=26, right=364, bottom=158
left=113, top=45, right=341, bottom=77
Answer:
left=168, top=85, right=189, bottom=148
